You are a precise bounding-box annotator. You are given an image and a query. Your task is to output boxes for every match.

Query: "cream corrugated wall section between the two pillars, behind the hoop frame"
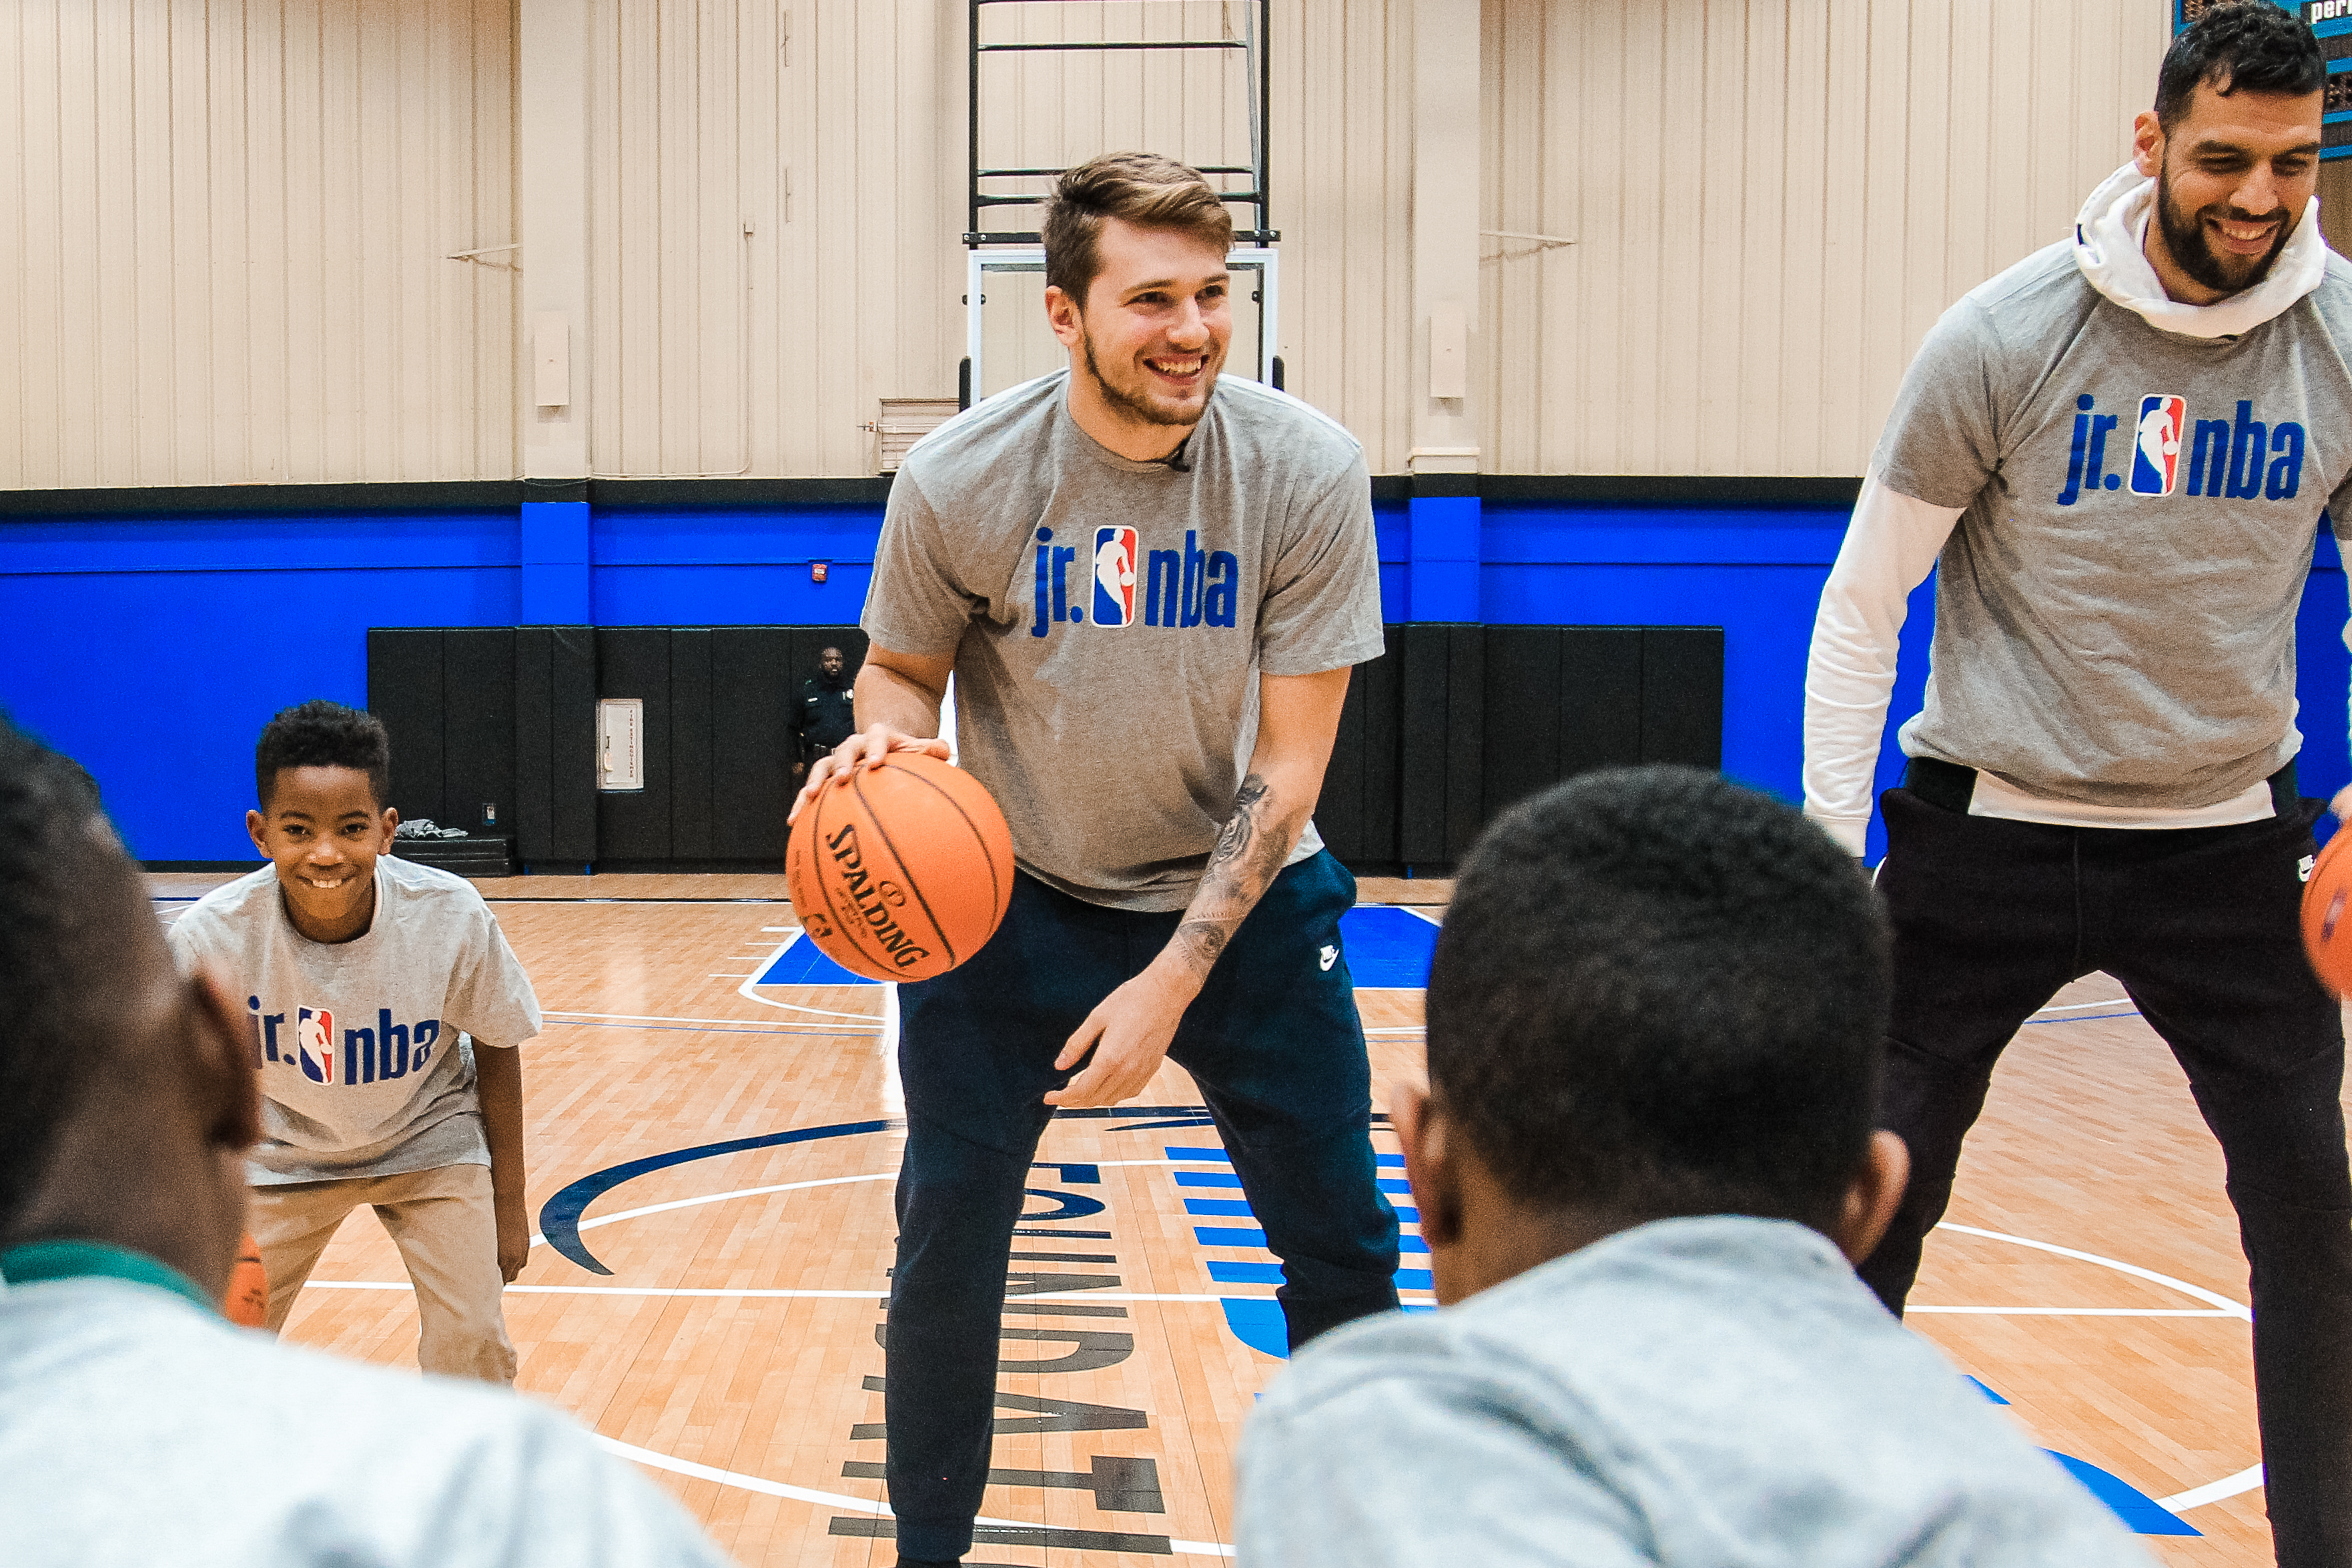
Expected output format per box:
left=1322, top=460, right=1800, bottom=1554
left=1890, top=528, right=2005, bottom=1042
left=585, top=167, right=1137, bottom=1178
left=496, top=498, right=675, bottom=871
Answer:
left=591, top=0, right=1411, bottom=475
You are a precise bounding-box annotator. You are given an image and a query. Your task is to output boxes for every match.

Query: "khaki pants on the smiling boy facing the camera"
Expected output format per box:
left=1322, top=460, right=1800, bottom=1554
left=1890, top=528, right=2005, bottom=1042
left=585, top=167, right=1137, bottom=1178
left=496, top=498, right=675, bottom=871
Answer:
left=252, top=1166, right=515, bottom=1385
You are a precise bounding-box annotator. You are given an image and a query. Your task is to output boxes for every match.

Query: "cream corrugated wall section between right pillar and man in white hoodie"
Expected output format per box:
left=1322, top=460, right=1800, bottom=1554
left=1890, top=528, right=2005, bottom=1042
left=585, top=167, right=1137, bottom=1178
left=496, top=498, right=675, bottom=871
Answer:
left=1479, top=0, right=2167, bottom=475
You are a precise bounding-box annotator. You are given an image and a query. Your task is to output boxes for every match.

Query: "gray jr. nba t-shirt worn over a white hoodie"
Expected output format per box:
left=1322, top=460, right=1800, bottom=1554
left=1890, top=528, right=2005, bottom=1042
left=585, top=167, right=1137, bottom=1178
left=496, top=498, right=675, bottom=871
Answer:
left=1872, top=242, right=2352, bottom=806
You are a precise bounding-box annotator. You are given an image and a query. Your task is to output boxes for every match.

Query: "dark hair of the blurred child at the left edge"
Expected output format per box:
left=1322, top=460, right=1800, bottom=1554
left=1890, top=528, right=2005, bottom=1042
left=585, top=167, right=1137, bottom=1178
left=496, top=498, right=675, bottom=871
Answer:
left=0, top=717, right=156, bottom=1236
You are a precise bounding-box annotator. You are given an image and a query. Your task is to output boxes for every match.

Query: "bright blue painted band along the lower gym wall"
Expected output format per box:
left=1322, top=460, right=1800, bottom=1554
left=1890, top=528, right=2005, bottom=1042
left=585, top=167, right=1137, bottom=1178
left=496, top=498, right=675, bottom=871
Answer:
left=0, top=496, right=2352, bottom=861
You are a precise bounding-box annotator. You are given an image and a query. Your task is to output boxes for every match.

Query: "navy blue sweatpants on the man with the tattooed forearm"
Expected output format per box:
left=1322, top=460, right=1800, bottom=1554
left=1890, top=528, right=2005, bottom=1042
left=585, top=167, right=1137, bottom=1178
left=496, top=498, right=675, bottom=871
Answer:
left=884, top=853, right=1397, bottom=1561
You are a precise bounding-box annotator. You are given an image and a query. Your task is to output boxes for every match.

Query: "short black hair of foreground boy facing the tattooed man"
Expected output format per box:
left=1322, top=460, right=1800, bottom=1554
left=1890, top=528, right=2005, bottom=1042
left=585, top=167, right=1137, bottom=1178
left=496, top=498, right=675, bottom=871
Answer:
left=1428, top=769, right=1891, bottom=1230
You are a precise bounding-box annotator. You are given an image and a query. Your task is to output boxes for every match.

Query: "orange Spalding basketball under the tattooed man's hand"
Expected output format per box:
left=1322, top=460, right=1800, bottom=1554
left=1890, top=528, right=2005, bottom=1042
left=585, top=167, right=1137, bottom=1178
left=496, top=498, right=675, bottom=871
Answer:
left=783, top=752, right=1014, bottom=980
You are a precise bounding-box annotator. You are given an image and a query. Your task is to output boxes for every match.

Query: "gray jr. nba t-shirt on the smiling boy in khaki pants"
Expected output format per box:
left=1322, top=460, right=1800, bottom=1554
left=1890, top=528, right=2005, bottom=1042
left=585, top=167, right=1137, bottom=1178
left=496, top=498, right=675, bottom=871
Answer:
left=171, top=855, right=538, bottom=1187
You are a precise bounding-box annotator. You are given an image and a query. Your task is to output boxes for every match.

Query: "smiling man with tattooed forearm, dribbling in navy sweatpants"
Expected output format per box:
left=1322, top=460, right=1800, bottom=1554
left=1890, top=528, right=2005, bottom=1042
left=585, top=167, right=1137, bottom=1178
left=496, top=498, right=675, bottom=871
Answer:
left=802, top=153, right=1397, bottom=1563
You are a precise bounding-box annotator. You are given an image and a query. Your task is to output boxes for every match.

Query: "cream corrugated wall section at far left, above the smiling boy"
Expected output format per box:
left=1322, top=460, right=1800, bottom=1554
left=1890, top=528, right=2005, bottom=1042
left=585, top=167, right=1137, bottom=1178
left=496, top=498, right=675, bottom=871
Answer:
left=0, top=0, right=515, bottom=489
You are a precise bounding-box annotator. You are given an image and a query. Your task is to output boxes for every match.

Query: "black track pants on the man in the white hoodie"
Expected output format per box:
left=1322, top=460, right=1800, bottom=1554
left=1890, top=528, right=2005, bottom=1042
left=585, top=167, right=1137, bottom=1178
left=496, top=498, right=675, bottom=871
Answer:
left=1860, top=790, right=2352, bottom=1568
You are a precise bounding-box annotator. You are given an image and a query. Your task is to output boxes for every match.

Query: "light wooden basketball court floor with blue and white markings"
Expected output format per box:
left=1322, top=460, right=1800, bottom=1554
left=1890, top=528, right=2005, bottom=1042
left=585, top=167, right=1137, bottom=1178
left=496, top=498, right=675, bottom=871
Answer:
left=153, top=875, right=2314, bottom=1568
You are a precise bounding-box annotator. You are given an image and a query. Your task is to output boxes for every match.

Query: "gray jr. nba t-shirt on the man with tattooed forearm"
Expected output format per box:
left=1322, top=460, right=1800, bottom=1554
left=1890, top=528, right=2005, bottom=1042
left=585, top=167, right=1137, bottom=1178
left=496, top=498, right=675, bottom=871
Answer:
left=863, top=372, right=1381, bottom=909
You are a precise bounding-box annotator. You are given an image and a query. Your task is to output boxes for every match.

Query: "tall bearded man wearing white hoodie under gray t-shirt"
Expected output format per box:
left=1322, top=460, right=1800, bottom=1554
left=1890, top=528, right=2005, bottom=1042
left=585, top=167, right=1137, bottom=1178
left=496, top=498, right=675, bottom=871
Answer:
left=1804, top=5, right=2352, bottom=1568
